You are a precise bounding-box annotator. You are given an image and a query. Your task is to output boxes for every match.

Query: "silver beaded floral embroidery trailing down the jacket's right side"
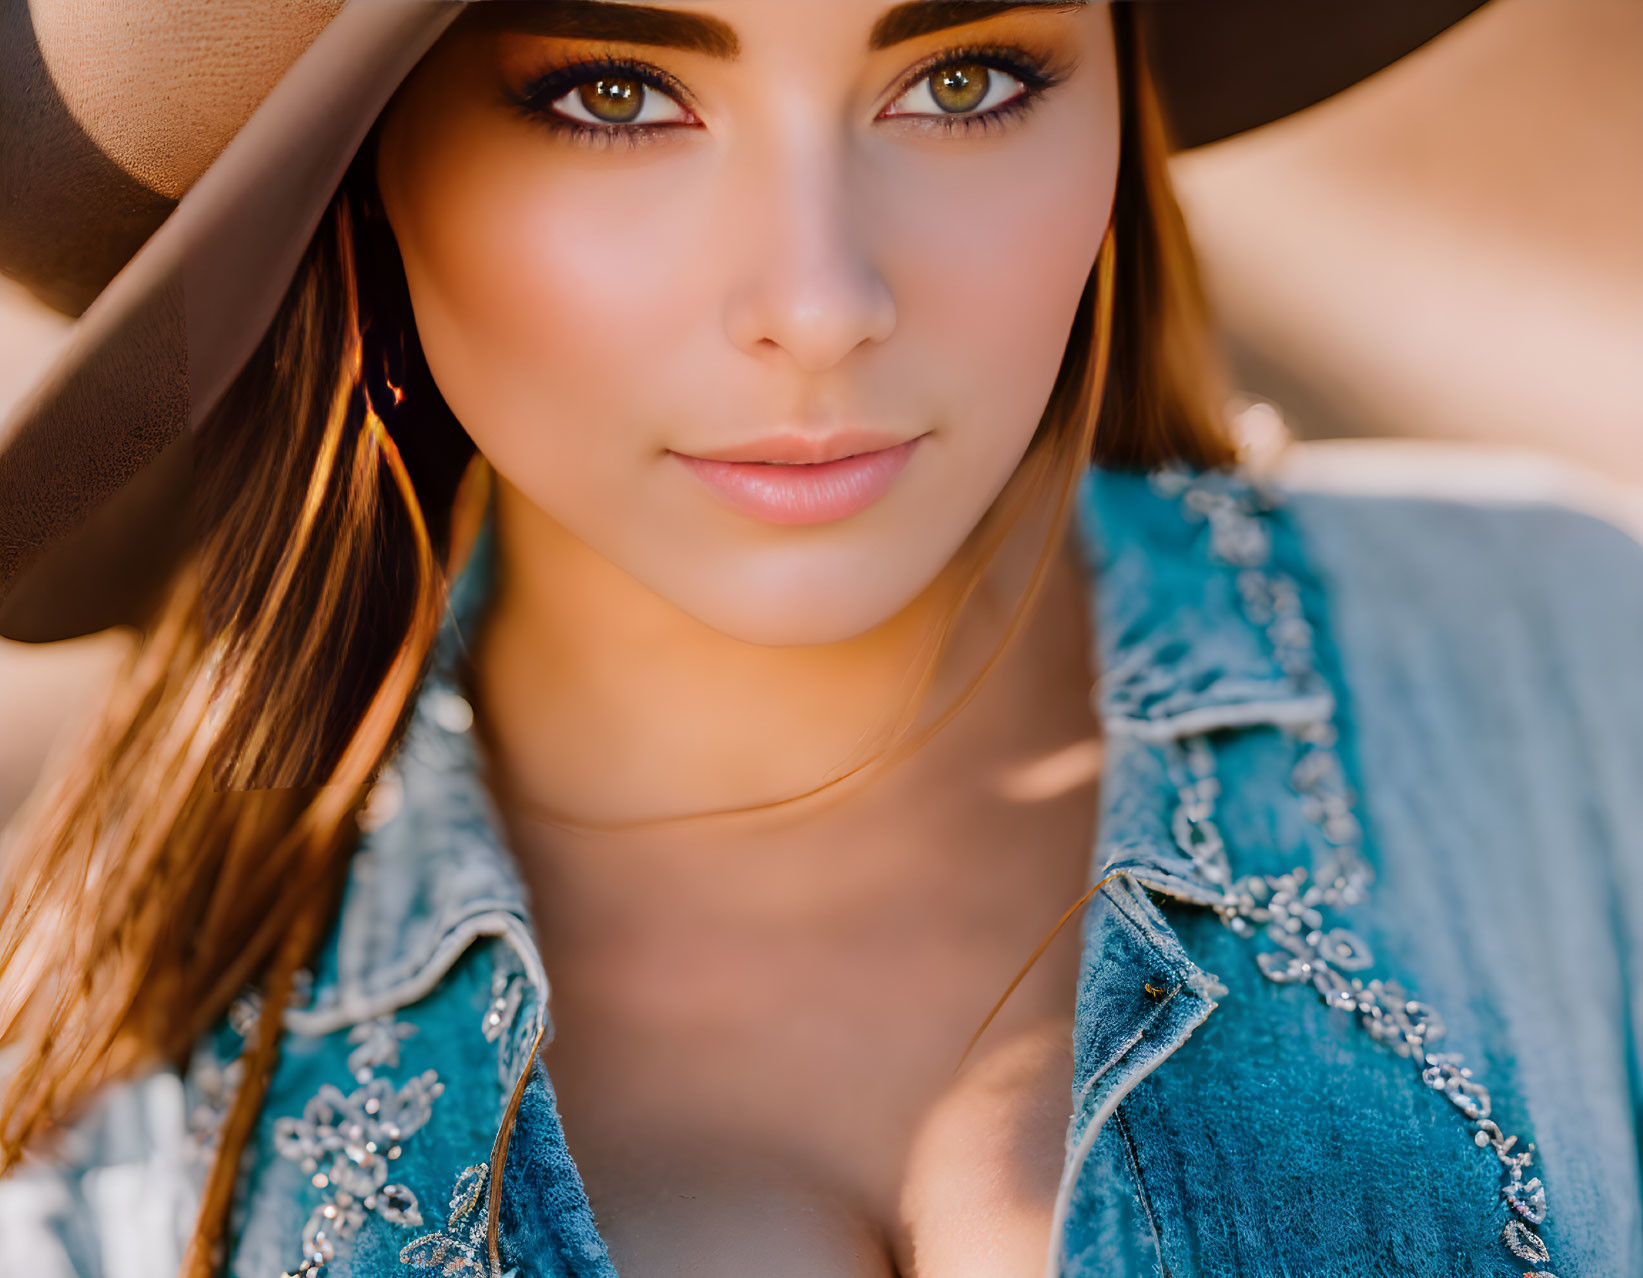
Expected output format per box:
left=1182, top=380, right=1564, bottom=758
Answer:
left=1153, top=470, right=1556, bottom=1278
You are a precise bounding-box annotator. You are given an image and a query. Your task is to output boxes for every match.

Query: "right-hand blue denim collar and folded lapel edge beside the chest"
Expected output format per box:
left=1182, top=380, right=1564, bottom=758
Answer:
left=1045, top=468, right=1336, bottom=1278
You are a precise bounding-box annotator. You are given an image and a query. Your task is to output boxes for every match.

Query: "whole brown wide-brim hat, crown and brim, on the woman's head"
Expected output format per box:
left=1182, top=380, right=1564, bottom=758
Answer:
left=0, top=0, right=1484, bottom=642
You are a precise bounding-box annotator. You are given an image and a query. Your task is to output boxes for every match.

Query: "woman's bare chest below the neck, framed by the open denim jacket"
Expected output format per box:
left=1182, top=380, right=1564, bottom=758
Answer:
left=506, top=555, right=1101, bottom=1278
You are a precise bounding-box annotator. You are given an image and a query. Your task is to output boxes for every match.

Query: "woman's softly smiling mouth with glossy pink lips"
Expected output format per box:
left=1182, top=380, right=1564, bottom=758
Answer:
left=674, top=435, right=923, bottom=524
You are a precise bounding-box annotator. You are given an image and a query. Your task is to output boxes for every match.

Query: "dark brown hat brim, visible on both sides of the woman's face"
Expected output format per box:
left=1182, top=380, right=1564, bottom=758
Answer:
left=0, top=0, right=1482, bottom=642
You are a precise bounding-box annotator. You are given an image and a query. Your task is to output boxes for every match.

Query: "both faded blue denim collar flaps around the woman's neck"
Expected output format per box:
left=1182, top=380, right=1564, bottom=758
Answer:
left=288, top=467, right=1334, bottom=1033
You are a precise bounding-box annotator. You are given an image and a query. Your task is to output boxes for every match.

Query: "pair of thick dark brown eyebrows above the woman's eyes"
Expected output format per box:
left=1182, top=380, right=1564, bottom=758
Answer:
left=473, top=0, right=1088, bottom=61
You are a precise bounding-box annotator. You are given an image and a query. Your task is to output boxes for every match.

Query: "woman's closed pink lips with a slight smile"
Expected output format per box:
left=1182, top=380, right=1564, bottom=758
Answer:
left=674, top=435, right=923, bottom=524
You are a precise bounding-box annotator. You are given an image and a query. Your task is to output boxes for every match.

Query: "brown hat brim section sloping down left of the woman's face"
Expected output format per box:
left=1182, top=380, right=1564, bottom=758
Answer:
left=0, top=0, right=465, bottom=642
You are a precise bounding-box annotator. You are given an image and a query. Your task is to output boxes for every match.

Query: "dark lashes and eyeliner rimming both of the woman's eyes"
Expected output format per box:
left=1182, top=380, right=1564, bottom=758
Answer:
left=511, top=44, right=1066, bottom=149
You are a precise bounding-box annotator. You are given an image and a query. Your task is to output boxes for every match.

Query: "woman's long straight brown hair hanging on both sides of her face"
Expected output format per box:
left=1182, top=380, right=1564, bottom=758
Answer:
left=0, top=7, right=1234, bottom=1273
